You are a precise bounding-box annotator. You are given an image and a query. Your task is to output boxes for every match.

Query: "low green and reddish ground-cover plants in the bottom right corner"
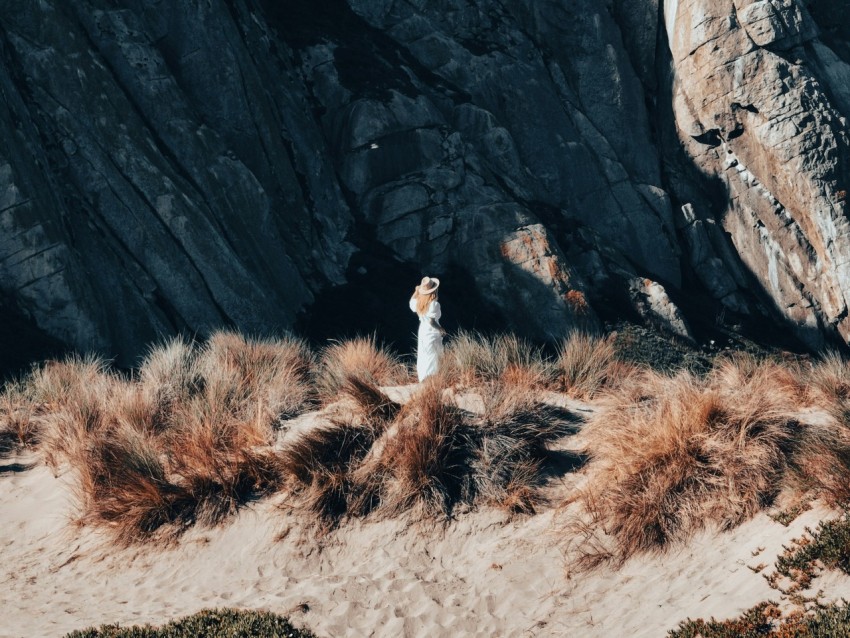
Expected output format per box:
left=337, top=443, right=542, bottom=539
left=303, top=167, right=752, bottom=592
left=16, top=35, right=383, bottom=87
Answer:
left=667, top=601, right=850, bottom=638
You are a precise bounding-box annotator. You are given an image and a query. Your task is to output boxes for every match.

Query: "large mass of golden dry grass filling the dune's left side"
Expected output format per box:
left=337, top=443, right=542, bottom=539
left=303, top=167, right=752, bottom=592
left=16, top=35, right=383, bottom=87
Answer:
left=0, top=332, right=313, bottom=542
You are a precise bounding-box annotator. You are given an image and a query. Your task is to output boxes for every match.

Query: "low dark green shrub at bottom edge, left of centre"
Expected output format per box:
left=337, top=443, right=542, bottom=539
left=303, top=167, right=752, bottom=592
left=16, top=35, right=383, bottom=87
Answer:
left=65, top=609, right=315, bottom=638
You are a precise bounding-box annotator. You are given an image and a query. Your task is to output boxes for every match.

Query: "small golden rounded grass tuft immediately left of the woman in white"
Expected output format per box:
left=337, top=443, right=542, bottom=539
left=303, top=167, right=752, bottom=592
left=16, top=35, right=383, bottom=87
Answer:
left=315, top=335, right=411, bottom=402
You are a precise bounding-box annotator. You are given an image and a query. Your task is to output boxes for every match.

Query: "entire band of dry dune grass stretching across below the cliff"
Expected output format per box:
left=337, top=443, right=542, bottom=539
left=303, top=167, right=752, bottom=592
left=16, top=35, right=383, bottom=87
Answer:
left=0, top=332, right=850, bottom=564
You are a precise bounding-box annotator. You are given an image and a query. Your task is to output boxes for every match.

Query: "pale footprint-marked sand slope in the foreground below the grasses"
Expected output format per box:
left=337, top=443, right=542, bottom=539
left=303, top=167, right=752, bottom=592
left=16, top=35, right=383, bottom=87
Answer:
left=0, top=398, right=850, bottom=638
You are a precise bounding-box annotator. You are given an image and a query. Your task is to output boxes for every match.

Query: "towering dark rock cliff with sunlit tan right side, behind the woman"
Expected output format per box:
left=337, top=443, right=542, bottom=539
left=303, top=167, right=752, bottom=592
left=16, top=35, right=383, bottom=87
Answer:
left=0, top=0, right=850, bottom=364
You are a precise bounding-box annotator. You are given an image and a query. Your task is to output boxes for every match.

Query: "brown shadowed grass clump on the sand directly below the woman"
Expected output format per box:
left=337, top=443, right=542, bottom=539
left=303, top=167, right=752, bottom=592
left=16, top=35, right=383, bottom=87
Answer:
left=281, top=375, right=575, bottom=529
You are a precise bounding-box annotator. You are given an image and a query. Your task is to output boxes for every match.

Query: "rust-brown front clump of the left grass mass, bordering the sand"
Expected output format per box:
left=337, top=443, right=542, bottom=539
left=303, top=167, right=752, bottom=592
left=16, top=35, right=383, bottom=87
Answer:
left=76, top=390, right=282, bottom=543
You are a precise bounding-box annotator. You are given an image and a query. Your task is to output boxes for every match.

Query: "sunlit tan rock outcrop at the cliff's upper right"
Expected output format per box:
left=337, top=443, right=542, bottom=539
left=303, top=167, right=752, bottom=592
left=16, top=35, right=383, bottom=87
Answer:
left=665, top=0, right=850, bottom=346
